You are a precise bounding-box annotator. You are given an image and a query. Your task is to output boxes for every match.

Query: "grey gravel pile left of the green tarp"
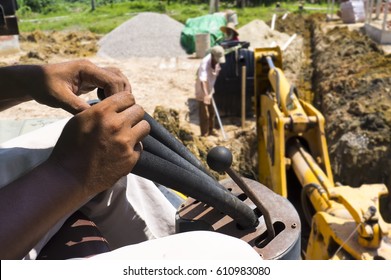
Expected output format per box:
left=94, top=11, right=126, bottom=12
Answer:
left=97, top=13, right=186, bottom=59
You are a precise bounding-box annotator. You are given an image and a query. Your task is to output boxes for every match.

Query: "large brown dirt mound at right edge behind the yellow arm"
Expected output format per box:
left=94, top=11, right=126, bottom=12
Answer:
left=313, top=17, right=391, bottom=218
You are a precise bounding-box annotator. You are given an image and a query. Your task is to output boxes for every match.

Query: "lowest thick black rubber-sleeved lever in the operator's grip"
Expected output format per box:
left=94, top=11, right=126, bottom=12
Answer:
left=132, top=151, right=258, bottom=228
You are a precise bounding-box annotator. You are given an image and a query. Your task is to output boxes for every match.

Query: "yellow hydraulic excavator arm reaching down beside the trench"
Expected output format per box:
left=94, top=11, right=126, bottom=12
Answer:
left=254, top=47, right=391, bottom=259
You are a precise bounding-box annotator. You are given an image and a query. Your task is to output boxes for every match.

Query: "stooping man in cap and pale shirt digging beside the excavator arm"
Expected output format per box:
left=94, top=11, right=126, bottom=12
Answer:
left=195, top=45, right=225, bottom=136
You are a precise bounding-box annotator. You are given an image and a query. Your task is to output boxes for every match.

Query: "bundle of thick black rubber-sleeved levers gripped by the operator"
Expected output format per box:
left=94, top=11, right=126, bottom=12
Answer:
left=95, top=89, right=258, bottom=228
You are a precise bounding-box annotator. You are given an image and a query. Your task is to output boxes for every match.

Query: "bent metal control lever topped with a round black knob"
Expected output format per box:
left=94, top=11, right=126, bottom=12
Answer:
left=206, top=146, right=276, bottom=240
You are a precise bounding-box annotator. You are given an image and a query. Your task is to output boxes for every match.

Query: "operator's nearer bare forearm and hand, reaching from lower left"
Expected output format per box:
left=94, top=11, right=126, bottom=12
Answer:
left=0, top=92, right=149, bottom=259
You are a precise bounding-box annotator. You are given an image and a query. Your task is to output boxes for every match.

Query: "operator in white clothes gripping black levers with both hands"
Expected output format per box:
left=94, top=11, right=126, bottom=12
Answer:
left=0, top=60, right=260, bottom=259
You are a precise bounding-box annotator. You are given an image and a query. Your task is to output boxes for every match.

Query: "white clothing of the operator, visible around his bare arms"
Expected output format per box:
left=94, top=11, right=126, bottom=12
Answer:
left=0, top=119, right=261, bottom=260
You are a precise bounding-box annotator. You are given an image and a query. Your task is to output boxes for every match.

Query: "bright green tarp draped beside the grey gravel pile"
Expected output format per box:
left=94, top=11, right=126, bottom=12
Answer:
left=181, top=13, right=227, bottom=54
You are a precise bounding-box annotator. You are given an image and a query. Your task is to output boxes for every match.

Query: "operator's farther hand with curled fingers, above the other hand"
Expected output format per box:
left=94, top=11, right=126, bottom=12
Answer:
left=39, top=60, right=131, bottom=114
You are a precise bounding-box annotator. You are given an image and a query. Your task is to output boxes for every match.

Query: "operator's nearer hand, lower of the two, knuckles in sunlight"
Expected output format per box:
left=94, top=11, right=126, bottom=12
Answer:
left=49, top=91, right=150, bottom=195
